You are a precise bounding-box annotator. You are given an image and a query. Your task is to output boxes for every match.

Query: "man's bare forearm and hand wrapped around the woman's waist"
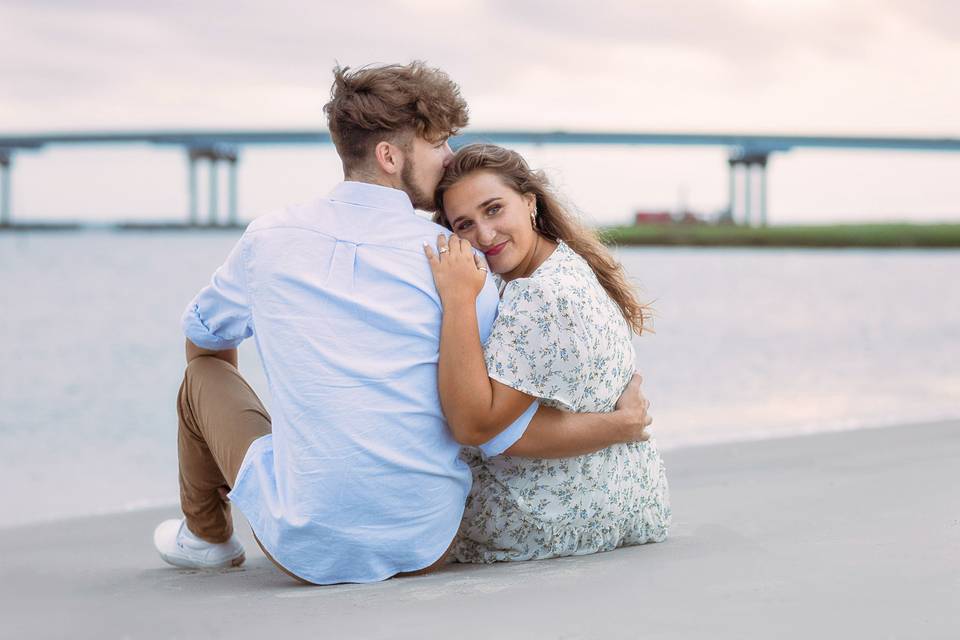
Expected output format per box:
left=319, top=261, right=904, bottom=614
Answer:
left=504, top=375, right=653, bottom=458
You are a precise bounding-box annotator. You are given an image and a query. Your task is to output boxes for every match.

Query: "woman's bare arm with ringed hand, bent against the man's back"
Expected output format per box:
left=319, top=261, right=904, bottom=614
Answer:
left=424, top=236, right=534, bottom=445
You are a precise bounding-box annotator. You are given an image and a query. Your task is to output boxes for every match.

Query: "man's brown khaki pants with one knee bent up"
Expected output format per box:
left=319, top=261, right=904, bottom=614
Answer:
left=177, top=356, right=454, bottom=582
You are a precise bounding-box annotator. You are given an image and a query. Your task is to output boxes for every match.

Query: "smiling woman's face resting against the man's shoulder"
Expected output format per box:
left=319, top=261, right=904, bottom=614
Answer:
left=443, top=171, right=537, bottom=280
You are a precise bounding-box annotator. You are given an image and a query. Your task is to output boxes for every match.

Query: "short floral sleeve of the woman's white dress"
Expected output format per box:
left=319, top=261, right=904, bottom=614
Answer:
left=484, top=279, right=589, bottom=411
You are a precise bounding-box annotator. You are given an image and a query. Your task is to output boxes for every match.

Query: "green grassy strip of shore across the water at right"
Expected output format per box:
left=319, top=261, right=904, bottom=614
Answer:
left=599, top=223, right=960, bottom=248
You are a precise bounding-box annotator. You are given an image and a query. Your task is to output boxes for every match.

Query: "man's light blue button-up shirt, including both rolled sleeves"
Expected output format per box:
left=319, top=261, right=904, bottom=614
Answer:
left=183, top=182, right=537, bottom=584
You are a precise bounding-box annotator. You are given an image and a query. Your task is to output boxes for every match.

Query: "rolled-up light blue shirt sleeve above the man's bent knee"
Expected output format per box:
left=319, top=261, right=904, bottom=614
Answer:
left=181, top=236, right=253, bottom=351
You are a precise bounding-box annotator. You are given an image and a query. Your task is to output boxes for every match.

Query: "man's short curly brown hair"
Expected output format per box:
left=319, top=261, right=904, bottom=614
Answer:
left=323, top=61, right=469, bottom=173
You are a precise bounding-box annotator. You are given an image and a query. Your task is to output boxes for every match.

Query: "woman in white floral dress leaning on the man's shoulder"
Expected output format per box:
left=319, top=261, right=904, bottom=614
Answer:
left=425, top=145, right=670, bottom=562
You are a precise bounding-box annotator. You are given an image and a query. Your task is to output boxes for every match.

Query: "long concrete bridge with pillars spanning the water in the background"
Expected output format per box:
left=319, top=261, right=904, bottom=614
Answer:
left=0, top=130, right=960, bottom=227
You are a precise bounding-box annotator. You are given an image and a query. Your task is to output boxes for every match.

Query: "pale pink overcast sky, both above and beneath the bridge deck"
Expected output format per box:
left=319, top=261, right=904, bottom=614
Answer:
left=0, top=0, right=960, bottom=219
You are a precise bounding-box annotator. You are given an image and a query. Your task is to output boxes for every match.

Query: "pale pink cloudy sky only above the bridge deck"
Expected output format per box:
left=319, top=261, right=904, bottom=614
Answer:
left=0, top=0, right=960, bottom=136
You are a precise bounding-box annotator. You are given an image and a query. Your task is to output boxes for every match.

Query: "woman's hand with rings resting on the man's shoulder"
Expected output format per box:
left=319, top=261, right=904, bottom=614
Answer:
left=423, top=234, right=487, bottom=307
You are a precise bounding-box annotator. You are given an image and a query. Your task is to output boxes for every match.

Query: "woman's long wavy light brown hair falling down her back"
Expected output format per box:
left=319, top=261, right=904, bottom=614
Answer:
left=433, top=144, right=651, bottom=335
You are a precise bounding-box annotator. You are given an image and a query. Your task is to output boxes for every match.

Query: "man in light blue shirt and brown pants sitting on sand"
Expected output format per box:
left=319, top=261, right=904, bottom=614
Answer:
left=154, top=63, right=649, bottom=584
